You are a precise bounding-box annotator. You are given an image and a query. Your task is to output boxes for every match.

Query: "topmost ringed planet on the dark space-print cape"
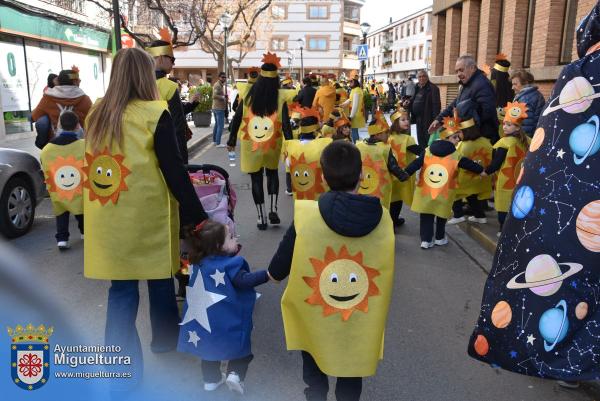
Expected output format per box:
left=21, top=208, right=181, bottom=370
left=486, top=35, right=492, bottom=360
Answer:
left=542, top=77, right=600, bottom=116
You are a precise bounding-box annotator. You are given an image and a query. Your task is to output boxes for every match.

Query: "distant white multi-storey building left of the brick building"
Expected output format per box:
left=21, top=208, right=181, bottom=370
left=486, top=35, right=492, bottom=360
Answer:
left=365, top=7, right=432, bottom=81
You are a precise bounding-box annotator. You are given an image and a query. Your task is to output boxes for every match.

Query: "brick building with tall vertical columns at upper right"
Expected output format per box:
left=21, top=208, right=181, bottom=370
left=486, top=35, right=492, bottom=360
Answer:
left=431, top=0, right=596, bottom=108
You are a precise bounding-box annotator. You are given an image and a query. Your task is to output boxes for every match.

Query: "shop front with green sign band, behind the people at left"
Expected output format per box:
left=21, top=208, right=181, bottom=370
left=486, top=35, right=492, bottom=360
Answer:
left=0, top=0, right=110, bottom=140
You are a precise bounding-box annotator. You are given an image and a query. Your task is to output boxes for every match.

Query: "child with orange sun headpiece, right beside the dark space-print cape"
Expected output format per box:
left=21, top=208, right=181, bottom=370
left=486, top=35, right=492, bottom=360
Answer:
left=485, top=102, right=530, bottom=235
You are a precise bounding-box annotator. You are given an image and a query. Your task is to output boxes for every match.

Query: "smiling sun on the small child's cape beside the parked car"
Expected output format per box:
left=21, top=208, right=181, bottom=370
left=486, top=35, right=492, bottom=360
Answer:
left=46, top=156, right=83, bottom=201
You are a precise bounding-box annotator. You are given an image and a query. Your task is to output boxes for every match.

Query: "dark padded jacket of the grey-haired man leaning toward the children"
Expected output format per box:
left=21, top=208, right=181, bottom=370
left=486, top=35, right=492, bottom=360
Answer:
left=436, top=69, right=498, bottom=142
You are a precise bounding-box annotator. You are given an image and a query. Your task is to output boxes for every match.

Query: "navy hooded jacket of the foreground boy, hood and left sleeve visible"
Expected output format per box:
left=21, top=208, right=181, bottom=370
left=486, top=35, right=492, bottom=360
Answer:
left=268, top=191, right=383, bottom=280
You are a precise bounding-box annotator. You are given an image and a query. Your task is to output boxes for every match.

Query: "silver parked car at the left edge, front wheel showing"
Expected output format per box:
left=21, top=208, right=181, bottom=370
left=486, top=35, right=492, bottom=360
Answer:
left=0, top=148, right=46, bottom=238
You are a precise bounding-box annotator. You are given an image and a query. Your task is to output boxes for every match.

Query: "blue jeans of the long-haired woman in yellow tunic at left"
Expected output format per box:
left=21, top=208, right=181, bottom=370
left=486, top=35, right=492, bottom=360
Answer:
left=105, top=278, right=179, bottom=391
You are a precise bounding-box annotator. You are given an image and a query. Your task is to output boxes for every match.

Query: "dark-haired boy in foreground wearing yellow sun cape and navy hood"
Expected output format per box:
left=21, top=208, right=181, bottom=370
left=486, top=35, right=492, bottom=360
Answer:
left=268, top=141, right=394, bottom=400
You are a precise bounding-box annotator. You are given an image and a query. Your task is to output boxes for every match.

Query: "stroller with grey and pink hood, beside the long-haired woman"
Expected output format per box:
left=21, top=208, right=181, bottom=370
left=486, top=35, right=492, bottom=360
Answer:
left=175, top=164, right=237, bottom=298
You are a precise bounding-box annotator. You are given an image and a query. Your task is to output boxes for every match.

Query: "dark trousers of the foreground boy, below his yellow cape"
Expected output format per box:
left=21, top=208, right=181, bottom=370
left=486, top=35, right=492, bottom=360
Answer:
left=302, top=351, right=362, bottom=401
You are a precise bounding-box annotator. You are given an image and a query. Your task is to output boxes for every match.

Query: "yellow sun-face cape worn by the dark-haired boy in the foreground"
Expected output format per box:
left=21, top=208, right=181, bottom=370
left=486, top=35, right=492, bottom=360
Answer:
left=281, top=200, right=394, bottom=377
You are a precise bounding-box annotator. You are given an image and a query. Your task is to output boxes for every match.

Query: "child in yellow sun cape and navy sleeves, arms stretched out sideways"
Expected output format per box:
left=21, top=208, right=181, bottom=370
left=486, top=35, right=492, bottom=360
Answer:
left=406, top=104, right=483, bottom=249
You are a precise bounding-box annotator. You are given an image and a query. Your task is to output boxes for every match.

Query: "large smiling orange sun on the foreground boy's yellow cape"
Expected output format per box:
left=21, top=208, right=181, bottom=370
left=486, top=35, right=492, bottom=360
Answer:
left=303, top=245, right=379, bottom=321
